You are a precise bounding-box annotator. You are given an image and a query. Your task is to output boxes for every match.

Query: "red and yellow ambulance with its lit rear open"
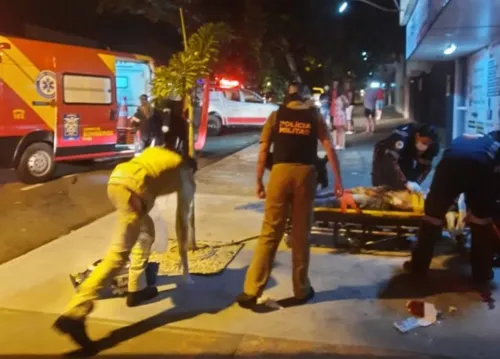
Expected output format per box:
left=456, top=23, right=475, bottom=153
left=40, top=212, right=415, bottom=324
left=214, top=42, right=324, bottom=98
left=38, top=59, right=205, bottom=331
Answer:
left=0, top=36, right=153, bottom=183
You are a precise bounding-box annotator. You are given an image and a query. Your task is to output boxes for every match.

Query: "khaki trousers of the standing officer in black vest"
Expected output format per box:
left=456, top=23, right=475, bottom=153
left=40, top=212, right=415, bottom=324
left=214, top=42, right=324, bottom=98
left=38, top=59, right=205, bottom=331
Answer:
left=244, top=163, right=317, bottom=299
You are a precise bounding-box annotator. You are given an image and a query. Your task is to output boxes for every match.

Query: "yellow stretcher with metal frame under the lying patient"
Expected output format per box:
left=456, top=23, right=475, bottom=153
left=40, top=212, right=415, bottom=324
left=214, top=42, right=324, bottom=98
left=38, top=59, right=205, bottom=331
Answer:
left=285, top=193, right=466, bottom=251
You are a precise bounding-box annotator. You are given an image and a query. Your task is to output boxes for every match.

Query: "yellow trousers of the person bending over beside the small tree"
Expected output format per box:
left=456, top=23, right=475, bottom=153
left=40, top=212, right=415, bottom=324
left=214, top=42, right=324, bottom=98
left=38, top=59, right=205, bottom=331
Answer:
left=64, top=184, right=155, bottom=318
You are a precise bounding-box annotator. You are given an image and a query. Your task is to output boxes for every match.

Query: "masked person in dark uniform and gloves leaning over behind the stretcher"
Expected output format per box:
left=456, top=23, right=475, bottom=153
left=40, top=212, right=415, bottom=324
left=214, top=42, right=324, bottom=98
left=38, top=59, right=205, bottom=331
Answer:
left=372, top=124, right=439, bottom=192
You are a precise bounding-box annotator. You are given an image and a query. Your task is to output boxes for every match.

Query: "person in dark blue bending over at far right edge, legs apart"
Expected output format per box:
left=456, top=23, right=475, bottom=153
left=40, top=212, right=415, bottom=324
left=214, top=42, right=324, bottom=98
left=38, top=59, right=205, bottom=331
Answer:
left=404, top=135, right=500, bottom=282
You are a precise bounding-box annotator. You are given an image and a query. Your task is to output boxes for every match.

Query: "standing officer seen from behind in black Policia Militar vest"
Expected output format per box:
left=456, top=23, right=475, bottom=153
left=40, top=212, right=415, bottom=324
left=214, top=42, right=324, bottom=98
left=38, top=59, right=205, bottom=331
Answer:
left=237, top=86, right=343, bottom=309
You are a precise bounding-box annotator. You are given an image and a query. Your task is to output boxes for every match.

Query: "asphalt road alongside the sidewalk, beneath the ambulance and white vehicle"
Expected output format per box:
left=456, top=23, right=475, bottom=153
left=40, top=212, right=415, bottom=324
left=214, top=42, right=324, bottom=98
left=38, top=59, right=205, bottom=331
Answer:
left=0, top=130, right=259, bottom=264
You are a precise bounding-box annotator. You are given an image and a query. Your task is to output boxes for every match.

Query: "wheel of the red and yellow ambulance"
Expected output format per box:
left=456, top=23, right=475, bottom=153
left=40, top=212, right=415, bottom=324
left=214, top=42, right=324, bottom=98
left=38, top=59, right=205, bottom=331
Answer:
left=17, top=142, right=56, bottom=184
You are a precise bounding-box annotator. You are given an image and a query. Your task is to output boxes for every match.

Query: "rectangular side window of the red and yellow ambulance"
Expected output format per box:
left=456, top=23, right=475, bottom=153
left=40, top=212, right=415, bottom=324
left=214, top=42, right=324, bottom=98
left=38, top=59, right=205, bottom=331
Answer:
left=63, top=74, right=112, bottom=105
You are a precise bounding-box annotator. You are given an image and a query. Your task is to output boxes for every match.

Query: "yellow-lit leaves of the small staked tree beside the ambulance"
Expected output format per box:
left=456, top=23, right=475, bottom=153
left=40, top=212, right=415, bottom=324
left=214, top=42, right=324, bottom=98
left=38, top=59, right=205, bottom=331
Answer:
left=153, top=22, right=232, bottom=98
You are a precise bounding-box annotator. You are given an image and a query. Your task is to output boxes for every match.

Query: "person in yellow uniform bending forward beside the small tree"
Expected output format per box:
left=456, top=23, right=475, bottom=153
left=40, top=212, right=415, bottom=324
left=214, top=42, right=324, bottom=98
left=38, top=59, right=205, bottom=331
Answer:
left=54, top=147, right=196, bottom=348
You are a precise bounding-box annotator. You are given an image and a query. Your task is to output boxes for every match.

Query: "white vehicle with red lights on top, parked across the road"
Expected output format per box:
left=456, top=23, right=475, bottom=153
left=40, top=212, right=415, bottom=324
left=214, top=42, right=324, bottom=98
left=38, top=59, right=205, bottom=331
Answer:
left=208, top=87, right=279, bottom=136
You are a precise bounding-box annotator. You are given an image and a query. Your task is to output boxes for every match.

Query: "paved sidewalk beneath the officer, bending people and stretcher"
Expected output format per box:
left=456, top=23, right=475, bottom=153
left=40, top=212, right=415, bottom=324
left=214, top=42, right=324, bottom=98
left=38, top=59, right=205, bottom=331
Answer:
left=0, top=113, right=500, bottom=359
